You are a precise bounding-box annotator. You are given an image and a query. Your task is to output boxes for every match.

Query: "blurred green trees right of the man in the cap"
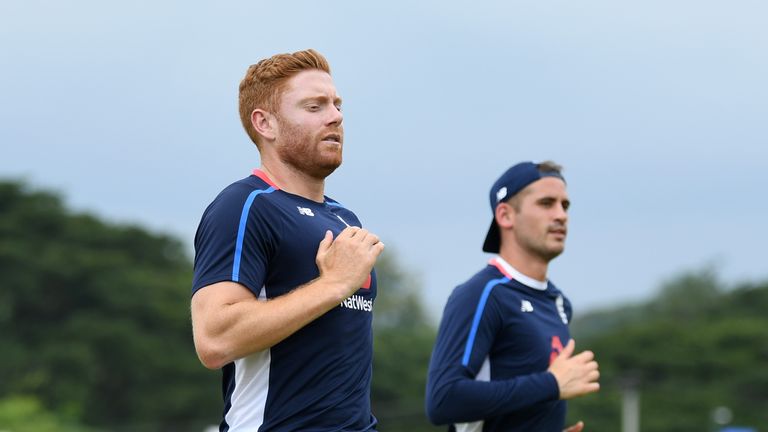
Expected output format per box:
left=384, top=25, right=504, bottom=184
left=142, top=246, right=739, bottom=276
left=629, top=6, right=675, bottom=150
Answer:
left=569, top=269, right=768, bottom=432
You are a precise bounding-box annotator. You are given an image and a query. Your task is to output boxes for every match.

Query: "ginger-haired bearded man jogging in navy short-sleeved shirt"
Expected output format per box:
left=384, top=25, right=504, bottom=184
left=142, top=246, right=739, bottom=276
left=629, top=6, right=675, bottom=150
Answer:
left=191, top=50, right=384, bottom=432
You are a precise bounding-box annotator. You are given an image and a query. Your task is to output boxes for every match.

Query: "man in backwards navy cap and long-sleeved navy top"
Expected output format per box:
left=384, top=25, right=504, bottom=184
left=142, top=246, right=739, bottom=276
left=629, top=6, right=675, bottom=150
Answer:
left=426, top=162, right=600, bottom=432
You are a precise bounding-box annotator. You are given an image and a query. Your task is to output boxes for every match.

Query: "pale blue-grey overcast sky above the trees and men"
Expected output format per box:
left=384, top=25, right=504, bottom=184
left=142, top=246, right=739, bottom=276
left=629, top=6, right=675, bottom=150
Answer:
left=0, top=0, right=768, bottom=316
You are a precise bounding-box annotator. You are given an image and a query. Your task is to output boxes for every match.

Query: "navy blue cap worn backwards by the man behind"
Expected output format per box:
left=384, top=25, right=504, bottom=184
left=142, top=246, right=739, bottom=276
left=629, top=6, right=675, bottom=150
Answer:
left=483, top=162, right=565, bottom=253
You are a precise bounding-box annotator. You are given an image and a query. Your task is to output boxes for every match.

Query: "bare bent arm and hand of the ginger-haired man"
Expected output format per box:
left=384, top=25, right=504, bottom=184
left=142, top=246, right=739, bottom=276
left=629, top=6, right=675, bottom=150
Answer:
left=192, top=227, right=384, bottom=369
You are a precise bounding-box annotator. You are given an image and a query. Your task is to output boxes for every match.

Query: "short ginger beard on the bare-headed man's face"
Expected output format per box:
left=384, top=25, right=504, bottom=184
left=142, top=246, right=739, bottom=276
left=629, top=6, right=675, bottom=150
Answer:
left=277, top=117, right=344, bottom=179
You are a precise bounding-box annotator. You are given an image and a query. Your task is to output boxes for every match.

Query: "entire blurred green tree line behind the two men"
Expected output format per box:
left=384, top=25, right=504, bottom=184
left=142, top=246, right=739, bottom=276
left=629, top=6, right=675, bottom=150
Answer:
left=0, top=180, right=768, bottom=432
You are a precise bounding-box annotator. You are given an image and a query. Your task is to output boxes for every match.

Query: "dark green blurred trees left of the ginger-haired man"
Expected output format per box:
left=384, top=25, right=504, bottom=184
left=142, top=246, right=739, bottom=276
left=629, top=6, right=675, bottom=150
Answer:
left=0, top=182, right=220, bottom=430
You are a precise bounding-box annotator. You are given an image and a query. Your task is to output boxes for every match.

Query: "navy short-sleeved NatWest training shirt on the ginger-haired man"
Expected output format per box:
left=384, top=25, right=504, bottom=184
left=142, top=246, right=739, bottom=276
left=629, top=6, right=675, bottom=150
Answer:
left=192, top=170, right=377, bottom=432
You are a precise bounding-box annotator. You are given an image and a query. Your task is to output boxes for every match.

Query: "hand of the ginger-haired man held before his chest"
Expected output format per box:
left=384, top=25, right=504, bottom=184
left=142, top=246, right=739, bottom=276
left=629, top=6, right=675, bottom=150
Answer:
left=315, top=227, right=384, bottom=301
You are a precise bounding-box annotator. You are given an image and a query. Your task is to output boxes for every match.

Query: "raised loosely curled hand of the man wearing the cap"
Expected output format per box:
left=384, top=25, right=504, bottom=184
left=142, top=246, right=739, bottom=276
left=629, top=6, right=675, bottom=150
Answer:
left=549, top=339, right=600, bottom=399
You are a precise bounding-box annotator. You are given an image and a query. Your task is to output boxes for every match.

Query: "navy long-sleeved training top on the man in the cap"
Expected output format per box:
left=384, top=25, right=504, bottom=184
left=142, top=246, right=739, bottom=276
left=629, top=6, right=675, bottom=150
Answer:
left=426, top=257, right=571, bottom=432
